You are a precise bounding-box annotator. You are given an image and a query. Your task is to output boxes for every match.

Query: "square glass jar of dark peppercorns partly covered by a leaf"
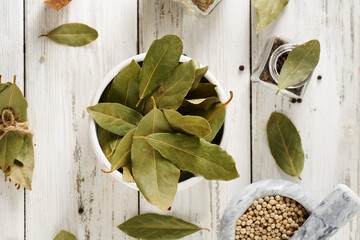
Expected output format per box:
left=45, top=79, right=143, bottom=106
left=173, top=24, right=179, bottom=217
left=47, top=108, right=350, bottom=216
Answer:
left=251, top=36, right=313, bottom=98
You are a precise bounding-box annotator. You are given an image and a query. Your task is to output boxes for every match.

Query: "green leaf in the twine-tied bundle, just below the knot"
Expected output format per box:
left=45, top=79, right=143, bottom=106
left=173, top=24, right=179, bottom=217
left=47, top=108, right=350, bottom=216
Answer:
left=0, top=131, right=24, bottom=172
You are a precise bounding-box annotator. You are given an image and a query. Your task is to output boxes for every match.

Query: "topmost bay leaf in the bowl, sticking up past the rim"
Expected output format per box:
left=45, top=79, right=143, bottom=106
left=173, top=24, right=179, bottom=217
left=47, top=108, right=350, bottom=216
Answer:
left=139, top=35, right=183, bottom=101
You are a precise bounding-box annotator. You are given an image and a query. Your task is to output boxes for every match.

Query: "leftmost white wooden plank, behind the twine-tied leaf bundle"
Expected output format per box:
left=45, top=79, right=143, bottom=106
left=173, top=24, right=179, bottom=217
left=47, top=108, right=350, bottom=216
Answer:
left=0, top=0, right=24, bottom=240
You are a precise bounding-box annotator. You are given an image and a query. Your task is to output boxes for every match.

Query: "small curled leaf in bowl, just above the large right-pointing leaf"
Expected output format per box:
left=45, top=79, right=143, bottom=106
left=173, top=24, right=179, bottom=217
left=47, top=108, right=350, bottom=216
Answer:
left=163, top=109, right=211, bottom=138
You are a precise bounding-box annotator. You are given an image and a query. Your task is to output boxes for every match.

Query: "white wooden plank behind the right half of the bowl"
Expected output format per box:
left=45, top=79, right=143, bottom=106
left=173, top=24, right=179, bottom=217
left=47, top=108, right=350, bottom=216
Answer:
left=139, top=0, right=250, bottom=239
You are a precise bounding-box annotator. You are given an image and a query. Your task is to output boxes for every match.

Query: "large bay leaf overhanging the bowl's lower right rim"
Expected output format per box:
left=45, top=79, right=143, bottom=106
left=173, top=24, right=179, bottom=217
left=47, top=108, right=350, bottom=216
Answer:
left=145, top=133, right=239, bottom=181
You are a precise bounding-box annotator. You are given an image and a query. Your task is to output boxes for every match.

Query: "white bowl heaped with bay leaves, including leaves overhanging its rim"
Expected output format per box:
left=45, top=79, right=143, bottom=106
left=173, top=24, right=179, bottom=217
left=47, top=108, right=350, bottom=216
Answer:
left=87, top=35, right=239, bottom=212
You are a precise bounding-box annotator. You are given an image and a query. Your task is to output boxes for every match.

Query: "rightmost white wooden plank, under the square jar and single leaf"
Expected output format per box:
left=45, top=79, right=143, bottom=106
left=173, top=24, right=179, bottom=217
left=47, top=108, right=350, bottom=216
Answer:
left=252, top=0, right=360, bottom=240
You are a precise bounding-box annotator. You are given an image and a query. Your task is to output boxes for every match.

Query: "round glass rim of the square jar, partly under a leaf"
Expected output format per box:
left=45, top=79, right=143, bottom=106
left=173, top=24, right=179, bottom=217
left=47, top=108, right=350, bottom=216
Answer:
left=269, top=44, right=309, bottom=89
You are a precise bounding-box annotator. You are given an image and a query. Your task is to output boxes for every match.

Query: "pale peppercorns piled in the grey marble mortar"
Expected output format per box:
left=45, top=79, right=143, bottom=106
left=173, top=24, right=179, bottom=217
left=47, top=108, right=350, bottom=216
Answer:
left=235, top=196, right=309, bottom=240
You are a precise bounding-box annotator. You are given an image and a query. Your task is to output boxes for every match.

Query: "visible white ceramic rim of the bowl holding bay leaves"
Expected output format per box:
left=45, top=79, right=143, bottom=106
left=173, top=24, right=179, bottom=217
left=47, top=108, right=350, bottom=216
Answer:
left=90, top=53, right=228, bottom=191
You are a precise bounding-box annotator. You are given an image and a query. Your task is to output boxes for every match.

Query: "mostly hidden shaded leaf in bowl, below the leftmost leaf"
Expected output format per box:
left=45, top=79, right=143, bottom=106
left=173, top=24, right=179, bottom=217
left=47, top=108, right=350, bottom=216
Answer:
left=97, top=126, right=121, bottom=159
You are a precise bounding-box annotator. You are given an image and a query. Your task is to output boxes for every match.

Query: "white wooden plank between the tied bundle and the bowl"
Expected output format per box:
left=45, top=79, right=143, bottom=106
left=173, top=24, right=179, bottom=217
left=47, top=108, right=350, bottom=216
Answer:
left=25, top=0, right=138, bottom=240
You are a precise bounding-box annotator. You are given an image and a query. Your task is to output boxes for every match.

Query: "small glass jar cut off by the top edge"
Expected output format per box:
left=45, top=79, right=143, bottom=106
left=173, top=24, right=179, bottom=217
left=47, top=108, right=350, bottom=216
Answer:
left=174, top=0, right=221, bottom=17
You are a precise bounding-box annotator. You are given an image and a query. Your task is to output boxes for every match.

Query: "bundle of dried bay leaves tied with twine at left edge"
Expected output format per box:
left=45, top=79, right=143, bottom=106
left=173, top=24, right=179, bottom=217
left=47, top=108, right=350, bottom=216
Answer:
left=0, top=76, right=34, bottom=190
